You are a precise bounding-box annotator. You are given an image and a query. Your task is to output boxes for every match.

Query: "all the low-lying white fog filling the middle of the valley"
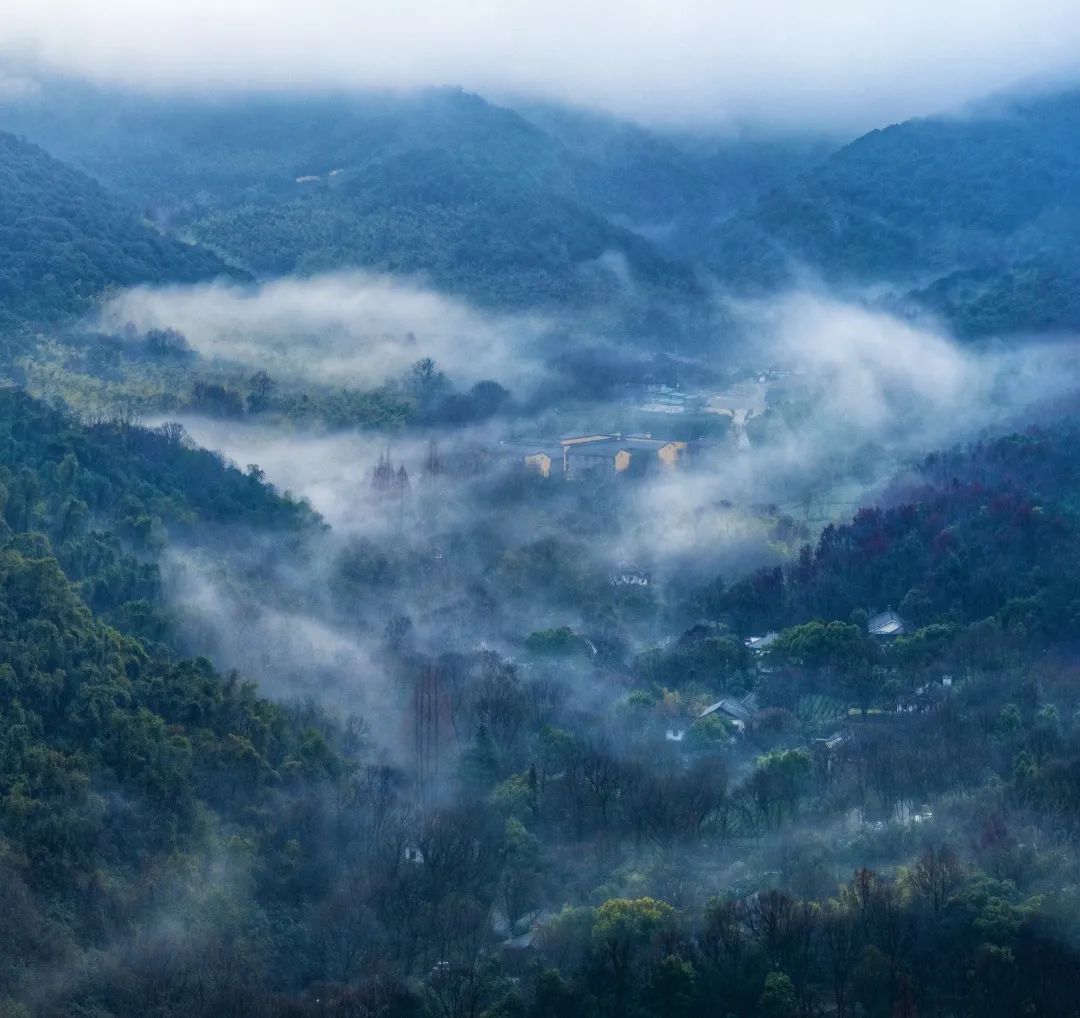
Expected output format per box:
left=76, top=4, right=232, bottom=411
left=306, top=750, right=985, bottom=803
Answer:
left=126, top=276, right=1078, bottom=734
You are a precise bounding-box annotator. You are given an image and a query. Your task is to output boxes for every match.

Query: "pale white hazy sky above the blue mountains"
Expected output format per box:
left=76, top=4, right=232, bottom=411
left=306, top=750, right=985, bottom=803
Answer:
left=6, top=0, right=1080, bottom=128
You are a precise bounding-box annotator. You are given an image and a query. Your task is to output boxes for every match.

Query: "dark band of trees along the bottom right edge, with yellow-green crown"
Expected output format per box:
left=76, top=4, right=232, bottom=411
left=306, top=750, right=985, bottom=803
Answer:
left=496, top=867, right=1078, bottom=1018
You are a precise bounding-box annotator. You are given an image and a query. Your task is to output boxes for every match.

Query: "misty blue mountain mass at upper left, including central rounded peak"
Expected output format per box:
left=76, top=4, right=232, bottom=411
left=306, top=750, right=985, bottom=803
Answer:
left=0, top=86, right=700, bottom=307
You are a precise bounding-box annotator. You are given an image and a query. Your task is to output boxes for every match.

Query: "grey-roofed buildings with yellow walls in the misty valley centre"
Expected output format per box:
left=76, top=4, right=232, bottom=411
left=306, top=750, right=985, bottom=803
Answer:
left=496, top=432, right=690, bottom=479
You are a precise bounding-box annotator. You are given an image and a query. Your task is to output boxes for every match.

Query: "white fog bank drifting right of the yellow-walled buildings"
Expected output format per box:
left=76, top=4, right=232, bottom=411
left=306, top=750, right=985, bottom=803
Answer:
left=627, top=293, right=1080, bottom=575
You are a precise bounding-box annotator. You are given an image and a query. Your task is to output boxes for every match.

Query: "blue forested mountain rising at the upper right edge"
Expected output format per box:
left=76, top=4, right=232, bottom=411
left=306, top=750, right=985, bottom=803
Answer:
left=710, top=93, right=1080, bottom=335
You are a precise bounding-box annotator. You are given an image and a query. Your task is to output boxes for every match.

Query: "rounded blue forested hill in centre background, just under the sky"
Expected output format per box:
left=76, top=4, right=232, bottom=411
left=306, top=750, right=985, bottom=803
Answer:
left=180, top=93, right=696, bottom=307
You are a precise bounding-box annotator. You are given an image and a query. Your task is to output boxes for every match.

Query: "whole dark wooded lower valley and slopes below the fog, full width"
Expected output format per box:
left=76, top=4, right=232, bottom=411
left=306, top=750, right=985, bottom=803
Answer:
left=0, top=369, right=1080, bottom=1018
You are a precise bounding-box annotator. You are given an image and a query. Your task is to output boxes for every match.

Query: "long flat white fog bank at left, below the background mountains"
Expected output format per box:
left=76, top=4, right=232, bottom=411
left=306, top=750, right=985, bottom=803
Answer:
left=100, top=271, right=545, bottom=386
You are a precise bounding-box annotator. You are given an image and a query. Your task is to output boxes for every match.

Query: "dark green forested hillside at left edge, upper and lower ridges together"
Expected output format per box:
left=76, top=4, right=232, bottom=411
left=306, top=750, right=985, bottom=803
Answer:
left=0, top=390, right=356, bottom=1016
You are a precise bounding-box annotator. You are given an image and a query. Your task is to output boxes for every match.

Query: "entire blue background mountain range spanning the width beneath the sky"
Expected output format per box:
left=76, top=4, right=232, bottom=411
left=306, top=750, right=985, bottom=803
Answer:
left=14, top=84, right=1080, bottom=336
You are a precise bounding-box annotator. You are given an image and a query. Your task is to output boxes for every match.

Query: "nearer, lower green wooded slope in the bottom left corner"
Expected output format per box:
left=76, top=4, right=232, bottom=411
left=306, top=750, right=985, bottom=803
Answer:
left=0, top=522, right=362, bottom=1015
